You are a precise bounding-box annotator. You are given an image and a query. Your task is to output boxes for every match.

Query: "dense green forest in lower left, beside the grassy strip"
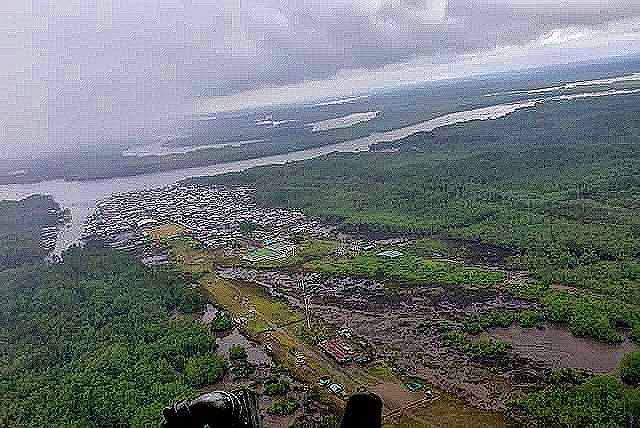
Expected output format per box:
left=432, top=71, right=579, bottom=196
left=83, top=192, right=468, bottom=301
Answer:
left=0, top=248, right=221, bottom=427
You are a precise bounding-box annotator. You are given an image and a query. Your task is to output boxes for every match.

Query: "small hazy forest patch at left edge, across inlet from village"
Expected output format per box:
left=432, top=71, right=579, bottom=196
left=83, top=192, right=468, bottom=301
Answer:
left=0, top=195, right=60, bottom=270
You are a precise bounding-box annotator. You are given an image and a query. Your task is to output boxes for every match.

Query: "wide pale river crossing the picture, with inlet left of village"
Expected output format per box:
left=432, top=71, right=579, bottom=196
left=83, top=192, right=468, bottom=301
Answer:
left=0, top=91, right=636, bottom=254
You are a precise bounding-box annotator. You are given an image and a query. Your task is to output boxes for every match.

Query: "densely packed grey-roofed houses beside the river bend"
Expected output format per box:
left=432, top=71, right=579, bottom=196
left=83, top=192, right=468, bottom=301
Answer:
left=82, top=184, right=318, bottom=264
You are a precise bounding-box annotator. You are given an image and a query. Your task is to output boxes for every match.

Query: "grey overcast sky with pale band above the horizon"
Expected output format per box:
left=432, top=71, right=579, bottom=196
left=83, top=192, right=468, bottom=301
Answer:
left=0, top=0, right=640, bottom=155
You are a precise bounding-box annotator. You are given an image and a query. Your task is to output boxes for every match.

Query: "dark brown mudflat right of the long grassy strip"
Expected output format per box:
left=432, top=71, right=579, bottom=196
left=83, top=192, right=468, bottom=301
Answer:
left=221, top=269, right=633, bottom=411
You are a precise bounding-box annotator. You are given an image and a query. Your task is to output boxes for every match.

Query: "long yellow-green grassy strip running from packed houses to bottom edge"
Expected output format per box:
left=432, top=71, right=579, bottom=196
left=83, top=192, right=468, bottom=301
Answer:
left=152, top=228, right=504, bottom=427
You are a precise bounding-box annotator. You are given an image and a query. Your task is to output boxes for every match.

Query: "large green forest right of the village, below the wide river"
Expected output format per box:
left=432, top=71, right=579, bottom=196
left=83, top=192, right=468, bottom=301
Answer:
left=198, top=101, right=640, bottom=342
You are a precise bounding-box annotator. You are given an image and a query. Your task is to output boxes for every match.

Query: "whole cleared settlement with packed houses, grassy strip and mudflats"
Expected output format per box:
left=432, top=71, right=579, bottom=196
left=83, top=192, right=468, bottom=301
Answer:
left=83, top=184, right=568, bottom=421
